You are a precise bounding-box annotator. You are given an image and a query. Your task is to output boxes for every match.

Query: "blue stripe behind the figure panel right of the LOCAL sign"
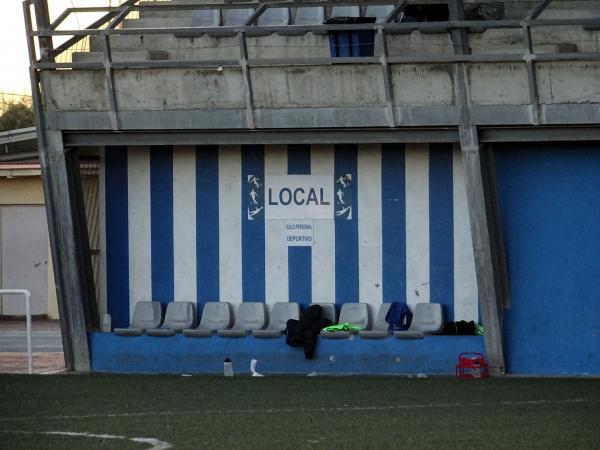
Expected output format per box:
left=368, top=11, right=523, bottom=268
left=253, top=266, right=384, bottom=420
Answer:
left=334, top=144, right=360, bottom=304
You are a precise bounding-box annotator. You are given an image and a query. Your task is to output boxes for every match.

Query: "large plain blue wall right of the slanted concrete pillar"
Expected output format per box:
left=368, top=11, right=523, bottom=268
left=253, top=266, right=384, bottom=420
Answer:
left=495, top=143, right=600, bottom=375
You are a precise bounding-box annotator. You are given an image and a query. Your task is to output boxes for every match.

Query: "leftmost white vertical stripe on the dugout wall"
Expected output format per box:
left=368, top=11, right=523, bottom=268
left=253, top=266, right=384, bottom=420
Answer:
left=127, top=147, right=153, bottom=317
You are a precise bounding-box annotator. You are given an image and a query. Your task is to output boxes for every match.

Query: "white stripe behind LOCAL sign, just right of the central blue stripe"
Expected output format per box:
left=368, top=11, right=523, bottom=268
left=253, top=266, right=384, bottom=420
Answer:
left=310, top=145, right=335, bottom=303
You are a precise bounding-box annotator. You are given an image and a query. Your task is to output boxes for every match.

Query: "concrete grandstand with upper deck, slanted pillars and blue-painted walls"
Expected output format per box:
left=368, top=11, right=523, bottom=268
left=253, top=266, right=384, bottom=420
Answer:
left=24, top=0, right=600, bottom=375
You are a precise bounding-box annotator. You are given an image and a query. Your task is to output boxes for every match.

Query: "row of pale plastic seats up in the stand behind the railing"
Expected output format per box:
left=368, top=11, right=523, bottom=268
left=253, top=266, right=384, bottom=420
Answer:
left=171, top=5, right=394, bottom=37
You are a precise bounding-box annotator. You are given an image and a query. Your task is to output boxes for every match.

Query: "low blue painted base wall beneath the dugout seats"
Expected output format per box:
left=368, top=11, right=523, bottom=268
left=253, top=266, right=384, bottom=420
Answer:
left=90, top=333, right=483, bottom=374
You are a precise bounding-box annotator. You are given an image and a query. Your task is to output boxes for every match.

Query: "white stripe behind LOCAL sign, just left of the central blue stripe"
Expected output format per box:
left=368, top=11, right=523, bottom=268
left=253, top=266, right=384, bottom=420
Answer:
left=265, top=145, right=289, bottom=305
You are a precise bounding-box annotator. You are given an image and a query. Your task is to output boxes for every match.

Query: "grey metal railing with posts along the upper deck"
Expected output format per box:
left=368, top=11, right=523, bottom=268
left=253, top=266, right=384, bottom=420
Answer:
left=24, top=0, right=600, bottom=134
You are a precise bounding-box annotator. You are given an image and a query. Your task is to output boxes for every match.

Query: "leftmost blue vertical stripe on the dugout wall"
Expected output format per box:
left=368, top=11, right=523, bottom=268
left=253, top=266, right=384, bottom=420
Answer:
left=104, top=147, right=129, bottom=328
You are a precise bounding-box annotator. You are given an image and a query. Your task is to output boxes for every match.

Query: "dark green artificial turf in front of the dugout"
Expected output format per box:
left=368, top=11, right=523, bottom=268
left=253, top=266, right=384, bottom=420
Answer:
left=0, top=375, right=600, bottom=450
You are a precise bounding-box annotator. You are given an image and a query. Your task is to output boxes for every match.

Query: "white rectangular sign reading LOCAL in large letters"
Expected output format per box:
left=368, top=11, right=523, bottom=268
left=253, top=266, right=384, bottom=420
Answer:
left=264, top=175, right=334, bottom=220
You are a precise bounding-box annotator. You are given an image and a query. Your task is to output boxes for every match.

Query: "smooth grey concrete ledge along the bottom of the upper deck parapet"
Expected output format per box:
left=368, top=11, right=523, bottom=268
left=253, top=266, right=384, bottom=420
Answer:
left=46, top=103, right=600, bottom=131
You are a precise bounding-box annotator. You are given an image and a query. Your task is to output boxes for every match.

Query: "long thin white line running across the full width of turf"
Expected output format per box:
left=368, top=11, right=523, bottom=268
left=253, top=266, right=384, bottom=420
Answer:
left=0, top=398, right=600, bottom=423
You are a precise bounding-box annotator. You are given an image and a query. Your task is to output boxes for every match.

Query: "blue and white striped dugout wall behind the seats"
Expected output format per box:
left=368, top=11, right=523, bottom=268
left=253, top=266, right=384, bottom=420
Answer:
left=101, top=144, right=478, bottom=326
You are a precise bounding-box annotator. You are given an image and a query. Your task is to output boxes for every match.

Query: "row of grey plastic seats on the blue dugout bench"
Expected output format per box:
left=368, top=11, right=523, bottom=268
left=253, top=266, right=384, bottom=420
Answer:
left=114, top=302, right=444, bottom=339
